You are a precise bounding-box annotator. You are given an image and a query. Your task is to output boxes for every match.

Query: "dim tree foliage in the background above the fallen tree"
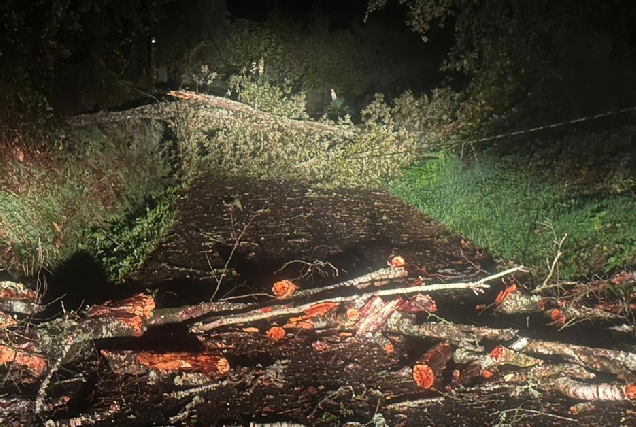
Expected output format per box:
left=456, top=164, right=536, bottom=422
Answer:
left=175, top=9, right=439, bottom=118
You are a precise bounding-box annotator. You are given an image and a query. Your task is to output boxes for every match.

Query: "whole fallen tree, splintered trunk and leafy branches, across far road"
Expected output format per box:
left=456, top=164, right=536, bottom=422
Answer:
left=66, top=91, right=434, bottom=188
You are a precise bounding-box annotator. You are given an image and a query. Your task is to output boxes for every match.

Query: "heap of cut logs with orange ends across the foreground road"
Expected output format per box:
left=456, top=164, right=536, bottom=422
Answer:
left=0, top=266, right=636, bottom=426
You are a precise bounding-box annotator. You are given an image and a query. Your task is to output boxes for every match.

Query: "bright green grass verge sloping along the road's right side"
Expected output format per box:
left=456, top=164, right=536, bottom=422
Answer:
left=392, top=153, right=636, bottom=279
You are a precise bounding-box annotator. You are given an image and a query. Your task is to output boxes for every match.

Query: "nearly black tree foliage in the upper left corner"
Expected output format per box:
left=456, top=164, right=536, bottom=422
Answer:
left=0, top=0, right=164, bottom=113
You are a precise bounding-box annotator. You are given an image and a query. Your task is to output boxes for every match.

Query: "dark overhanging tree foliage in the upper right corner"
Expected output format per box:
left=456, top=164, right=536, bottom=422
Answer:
left=367, top=0, right=636, bottom=126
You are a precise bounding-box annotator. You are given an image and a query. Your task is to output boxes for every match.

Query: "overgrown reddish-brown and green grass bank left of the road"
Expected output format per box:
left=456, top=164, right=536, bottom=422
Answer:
left=0, top=121, right=174, bottom=280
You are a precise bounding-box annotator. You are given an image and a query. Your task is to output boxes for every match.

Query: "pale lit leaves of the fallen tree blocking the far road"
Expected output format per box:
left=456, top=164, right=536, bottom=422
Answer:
left=166, top=75, right=456, bottom=187
